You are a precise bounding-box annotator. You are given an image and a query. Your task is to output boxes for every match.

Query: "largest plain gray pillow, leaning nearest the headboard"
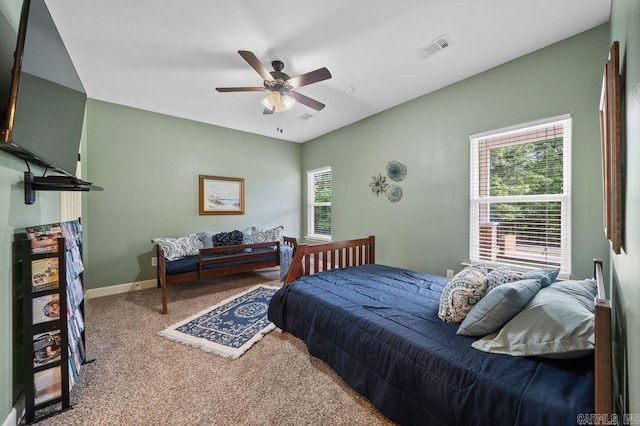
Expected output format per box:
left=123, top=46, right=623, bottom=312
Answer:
left=471, top=279, right=596, bottom=358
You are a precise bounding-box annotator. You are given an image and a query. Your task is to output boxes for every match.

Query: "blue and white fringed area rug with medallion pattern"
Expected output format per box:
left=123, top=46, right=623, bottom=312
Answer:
left=158, top=286, right=279, bottom=359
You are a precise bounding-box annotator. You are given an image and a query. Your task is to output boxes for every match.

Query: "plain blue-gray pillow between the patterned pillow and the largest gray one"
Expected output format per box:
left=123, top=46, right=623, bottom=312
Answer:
left=458, top=280, right=540, bottom=336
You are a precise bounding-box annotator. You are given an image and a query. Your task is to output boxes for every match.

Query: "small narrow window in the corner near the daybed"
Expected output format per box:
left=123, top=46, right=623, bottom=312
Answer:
left=307, top=167, right=331, bottom=240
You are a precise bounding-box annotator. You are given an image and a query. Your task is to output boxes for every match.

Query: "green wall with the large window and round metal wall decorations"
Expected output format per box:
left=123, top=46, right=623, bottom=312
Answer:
left=302, top=25, right=608, bottom=277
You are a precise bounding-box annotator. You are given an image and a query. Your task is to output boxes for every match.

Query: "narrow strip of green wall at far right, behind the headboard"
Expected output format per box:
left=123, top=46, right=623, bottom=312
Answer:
left=610, top=0, right=640, bottom=413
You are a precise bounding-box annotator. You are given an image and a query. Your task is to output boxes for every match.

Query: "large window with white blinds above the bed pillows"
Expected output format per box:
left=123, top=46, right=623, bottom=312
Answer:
left=470, top=115, right=571, bottom=277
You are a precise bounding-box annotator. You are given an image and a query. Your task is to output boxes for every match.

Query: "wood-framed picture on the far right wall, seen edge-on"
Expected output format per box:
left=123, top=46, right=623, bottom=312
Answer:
left=600, top=41, right=622, bottom=254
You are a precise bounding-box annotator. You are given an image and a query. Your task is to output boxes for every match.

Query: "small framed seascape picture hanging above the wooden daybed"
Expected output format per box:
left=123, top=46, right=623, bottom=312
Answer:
left=199, top=175, right=244, bottom=215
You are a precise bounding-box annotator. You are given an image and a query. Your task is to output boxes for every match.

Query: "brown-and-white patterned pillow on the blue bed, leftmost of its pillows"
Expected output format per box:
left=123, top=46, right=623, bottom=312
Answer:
left=438, top=263, right=488, bottom=323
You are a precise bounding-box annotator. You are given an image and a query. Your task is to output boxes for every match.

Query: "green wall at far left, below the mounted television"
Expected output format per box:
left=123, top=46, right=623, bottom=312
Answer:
left=0, top=156, right=60, bottom=421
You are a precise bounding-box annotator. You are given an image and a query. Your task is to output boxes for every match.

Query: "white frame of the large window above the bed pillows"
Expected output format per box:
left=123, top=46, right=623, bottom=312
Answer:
left=469, top=114, right=573, bottom=278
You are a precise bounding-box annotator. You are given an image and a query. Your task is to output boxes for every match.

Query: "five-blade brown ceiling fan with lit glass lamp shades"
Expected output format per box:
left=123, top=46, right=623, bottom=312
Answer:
left=216, top=50, right=331, bottom=114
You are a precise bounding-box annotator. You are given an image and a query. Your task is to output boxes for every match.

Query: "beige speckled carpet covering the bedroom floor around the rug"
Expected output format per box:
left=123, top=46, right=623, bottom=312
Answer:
left=39, top=269, right=390, bottom=425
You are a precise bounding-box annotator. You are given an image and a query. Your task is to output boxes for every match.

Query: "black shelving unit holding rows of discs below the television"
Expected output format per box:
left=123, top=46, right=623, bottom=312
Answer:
left=21, top=224, right=86, bottom=423
